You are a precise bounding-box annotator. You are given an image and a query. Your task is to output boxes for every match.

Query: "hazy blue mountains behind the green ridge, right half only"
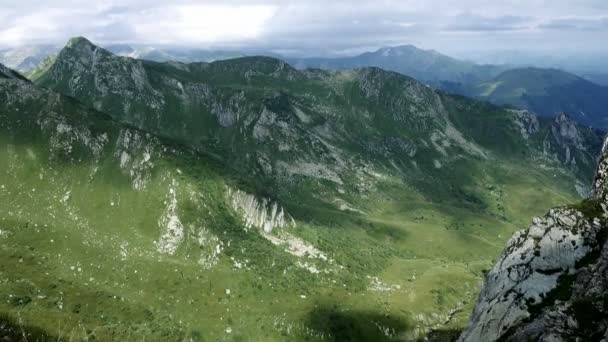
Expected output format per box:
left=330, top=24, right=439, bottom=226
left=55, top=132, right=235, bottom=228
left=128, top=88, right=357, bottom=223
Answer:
left=289, top=45, right=608, bottom=128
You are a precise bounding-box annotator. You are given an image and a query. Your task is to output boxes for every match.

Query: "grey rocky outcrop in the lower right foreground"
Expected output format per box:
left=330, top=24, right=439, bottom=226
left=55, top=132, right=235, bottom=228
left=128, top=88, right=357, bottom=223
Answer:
left=459, top=140, right=608, bottom=342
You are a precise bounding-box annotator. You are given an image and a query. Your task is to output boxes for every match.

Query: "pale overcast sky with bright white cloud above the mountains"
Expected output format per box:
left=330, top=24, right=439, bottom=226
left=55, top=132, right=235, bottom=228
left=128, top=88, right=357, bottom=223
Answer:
left=0, top=0, right=608, bottom=55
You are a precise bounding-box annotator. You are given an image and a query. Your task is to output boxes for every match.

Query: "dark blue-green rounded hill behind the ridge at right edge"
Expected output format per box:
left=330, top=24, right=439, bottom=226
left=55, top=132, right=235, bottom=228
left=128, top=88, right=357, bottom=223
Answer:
left=443, top=68, right=608, bottom=128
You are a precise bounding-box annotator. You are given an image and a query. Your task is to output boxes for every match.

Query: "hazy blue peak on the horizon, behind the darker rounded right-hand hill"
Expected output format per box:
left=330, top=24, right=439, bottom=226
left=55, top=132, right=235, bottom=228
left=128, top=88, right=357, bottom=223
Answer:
left=287, top=45, right=508, bottom=84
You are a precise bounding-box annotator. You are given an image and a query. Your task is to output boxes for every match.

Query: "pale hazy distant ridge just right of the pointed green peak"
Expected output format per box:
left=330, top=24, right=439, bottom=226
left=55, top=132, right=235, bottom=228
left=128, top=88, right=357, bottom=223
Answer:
left=106, top=44, right=245, bottom=63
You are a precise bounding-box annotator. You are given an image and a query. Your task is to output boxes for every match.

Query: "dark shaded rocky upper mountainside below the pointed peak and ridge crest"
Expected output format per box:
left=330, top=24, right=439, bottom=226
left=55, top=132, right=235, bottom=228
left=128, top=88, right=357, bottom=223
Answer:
left=35, top=38, right=594, bottom=184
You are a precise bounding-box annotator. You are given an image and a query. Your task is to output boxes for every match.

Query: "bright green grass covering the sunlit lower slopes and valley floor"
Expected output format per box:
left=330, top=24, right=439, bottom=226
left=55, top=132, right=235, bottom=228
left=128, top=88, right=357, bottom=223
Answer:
left=0, top=130, right=575, bottom=340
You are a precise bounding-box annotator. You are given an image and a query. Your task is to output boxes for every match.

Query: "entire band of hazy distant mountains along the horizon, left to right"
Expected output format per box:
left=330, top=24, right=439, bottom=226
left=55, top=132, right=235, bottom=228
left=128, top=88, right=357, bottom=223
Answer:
left=0, top=44, right=608, bottom=128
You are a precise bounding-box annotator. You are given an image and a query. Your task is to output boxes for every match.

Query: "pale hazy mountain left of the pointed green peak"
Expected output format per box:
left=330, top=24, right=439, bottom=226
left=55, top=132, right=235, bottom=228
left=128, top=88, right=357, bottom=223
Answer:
left=0, top=45, right=60, bottom=72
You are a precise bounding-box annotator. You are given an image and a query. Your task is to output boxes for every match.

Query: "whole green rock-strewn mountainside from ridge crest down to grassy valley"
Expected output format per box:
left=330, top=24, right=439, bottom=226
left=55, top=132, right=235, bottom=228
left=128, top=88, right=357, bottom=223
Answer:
left=0, top=39, right=600, bottom=340
